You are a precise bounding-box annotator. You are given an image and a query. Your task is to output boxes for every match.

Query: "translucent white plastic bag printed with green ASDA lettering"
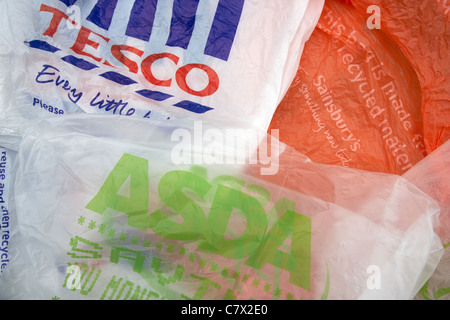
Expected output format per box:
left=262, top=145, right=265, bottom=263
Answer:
left=0, top=114, right=442, bottom=300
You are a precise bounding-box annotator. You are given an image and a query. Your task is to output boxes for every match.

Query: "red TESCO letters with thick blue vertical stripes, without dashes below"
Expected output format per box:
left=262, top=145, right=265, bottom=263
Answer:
left=35, top=0, right=244, bottom=97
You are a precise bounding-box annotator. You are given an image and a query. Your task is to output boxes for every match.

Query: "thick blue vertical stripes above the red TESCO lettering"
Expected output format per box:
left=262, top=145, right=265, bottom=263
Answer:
left=60, top=0, right=245, bottom=61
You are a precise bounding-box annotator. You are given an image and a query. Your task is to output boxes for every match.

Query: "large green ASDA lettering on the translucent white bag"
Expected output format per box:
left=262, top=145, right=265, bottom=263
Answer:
left=82, top=154, right=312, bottom=291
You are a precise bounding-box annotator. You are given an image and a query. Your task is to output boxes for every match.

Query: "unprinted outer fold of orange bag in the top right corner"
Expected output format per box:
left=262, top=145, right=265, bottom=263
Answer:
left=351, top=0, right=450, bottom=153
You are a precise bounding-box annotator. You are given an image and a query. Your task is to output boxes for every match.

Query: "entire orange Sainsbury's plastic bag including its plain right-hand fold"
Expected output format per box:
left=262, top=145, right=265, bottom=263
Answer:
left=269, top=0, right=450, bottom=174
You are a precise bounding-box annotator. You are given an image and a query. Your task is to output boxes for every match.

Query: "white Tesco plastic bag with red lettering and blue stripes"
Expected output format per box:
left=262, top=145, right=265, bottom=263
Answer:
left=0, top=0, right=323, bottom=134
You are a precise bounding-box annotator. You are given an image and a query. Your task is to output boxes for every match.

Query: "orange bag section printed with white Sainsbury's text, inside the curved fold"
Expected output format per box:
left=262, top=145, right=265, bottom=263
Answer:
left=270, top=0, right=426, bottom=174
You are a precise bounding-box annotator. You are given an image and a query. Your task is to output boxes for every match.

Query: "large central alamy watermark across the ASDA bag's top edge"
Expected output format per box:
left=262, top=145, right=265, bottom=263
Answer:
left=171, top=121, right=281, bottom=175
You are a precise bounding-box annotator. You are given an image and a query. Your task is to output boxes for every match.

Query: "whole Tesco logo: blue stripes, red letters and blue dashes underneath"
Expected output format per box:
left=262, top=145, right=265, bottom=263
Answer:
left=25, top=0, right=244, bottom=117
